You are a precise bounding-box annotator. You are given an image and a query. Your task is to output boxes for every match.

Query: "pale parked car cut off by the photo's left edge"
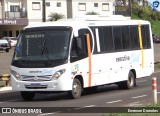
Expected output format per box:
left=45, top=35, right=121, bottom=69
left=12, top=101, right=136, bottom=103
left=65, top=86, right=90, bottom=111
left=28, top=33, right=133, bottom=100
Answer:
left=0, top=39, right=11, bottom=52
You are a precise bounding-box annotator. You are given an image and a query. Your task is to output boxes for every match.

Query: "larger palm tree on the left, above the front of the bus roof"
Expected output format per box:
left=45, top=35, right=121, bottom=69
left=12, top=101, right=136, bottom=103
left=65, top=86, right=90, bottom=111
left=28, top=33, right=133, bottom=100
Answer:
left=48, top=12, right=65, bottom=21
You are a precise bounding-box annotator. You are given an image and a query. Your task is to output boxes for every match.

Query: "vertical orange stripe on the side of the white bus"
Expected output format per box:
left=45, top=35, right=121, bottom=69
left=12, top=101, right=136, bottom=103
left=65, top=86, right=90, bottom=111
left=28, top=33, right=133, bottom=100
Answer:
left=86, top=34, right=92, bottom=87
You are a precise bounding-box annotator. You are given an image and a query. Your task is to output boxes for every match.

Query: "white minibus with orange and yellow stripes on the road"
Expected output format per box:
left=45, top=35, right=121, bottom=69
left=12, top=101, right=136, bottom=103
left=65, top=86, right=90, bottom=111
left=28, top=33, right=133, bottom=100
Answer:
left=10, top=15, right=154, bottom=100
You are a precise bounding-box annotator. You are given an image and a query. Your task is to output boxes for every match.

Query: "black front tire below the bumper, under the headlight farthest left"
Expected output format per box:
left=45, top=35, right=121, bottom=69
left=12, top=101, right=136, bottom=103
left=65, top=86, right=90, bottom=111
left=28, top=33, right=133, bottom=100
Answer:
left=21, top=91, right=35, bottom=101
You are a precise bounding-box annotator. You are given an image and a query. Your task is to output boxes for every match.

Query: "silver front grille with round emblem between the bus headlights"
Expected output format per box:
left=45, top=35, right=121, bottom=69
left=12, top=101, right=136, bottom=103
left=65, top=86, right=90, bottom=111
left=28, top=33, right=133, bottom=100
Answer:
left=22, top=75, right=52, bottom=81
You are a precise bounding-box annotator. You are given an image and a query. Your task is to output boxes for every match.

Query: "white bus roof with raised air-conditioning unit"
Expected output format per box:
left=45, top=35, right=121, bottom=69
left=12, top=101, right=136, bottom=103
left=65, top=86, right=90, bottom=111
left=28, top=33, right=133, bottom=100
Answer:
left=25, top=15, right=150, bottom=28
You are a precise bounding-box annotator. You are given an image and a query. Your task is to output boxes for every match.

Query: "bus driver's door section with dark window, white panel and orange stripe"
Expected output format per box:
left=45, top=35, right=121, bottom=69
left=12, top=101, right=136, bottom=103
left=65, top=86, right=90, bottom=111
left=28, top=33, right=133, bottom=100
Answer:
left=70, top=29, right=97, bottom=87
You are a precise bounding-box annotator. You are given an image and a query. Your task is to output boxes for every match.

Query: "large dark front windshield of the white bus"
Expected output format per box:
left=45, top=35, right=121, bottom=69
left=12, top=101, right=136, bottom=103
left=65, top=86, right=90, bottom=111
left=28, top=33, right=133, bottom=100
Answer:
left=12, top=27, right=71, bottom=68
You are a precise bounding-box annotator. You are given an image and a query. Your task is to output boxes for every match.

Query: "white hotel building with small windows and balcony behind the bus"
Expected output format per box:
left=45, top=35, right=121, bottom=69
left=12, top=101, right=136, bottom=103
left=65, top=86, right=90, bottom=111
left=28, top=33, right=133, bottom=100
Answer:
left=0, top=0, right=115, bottom=38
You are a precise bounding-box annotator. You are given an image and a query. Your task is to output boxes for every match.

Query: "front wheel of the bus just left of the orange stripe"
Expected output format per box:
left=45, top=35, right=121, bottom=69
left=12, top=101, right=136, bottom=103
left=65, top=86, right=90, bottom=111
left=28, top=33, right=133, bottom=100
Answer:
left=69, top=79, right=82, bottom=99
